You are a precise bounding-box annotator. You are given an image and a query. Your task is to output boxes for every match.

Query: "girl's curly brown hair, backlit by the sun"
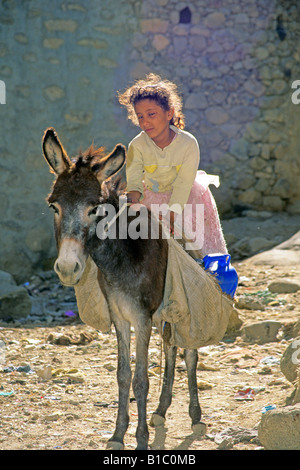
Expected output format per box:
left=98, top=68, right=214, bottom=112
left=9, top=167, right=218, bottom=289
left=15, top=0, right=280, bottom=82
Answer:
left=118, top=73, right=184, bottom=129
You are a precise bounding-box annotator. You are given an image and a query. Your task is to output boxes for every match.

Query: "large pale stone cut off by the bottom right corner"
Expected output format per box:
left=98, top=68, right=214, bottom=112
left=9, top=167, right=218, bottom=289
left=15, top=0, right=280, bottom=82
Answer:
left=258, top=404, right=300, bottom=450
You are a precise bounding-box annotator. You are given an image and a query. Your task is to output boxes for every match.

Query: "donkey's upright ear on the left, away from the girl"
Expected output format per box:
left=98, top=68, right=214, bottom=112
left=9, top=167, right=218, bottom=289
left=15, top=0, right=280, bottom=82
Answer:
left=42, top=127, right=71, bottom=175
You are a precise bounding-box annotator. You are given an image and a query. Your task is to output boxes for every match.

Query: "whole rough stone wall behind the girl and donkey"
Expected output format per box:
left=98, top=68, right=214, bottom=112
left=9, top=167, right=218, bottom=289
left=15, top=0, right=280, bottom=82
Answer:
left=0, top=0, right=300, bottom=280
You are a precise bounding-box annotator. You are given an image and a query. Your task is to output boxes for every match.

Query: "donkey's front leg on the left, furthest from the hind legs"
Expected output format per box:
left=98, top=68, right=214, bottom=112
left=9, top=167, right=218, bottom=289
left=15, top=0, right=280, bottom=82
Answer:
left=107, top=320, right=131, bottom=450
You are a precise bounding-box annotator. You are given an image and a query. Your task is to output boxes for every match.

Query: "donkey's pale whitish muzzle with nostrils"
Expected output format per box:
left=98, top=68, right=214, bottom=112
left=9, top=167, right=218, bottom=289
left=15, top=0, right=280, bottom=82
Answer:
left=54, top=238, right=85, bottom=286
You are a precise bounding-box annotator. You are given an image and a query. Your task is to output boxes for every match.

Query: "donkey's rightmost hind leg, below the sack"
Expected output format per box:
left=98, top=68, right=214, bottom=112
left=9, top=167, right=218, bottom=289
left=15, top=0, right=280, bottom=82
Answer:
left=184, top=349, right=206, bottom=435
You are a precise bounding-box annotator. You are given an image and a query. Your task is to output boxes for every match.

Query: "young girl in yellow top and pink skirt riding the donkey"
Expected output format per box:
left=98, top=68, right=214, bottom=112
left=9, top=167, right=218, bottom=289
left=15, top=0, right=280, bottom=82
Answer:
left=118, top=73, right=227, bottom=256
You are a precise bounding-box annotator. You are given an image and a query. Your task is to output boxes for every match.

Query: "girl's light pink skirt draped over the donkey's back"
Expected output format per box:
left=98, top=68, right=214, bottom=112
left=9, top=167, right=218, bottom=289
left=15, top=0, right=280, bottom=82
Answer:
left=141, top=172, right=228, bottom=256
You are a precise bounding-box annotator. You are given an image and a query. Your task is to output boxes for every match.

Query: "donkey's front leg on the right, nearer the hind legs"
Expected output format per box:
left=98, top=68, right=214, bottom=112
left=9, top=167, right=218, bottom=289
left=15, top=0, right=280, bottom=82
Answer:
left=132, top=318, right=152, bottom=450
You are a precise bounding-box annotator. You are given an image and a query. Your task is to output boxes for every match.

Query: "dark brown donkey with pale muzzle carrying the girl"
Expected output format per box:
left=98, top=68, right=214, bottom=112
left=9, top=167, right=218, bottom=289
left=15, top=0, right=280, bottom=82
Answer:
left=42, top=128, right=201, bottom=449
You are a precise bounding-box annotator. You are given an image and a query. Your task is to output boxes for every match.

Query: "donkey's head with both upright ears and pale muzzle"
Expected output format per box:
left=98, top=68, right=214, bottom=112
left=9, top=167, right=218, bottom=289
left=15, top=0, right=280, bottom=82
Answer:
left=42, top=128, right=125, bottom=286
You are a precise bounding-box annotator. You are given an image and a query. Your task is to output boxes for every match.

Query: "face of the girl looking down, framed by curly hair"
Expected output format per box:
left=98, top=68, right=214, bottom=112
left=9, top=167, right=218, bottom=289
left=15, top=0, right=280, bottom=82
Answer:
left=134, top=98, right=174, bottom=143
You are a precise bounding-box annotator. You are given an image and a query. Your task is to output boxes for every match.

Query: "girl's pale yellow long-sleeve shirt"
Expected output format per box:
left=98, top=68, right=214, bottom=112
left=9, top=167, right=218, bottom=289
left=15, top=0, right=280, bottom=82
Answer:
left=126, top=126, right=200, bottom=212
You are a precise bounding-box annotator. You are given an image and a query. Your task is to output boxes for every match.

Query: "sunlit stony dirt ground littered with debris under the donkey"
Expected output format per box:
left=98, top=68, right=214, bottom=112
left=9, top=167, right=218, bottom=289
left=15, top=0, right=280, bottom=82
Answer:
left=0, top=252, right=300, bottom=450
